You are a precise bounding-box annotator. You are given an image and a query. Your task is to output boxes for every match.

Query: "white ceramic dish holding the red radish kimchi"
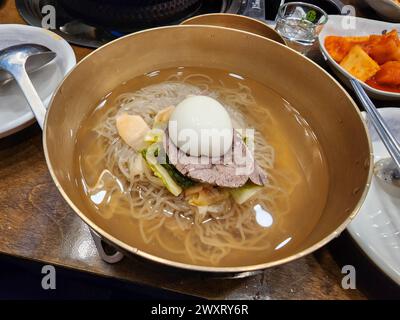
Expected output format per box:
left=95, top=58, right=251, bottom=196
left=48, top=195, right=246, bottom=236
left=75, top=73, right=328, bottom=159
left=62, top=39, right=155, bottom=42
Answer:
left=319, top=15, right=400, bottom=101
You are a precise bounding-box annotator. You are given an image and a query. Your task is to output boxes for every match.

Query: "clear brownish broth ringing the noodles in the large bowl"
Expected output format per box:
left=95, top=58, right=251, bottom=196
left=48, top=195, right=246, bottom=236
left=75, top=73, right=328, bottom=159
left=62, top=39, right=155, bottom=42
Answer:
left=74, top=67, right=329, bottom=267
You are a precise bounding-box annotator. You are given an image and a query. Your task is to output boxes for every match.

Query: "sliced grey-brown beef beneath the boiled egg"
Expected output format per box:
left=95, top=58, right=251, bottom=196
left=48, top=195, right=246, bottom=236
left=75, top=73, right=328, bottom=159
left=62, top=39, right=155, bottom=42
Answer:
left=165, top=131, right=267, bottom=188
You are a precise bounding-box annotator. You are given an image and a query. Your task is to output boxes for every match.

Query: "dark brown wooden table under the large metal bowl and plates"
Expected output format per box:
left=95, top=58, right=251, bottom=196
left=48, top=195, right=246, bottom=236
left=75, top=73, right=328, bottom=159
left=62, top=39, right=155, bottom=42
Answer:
left=0, top=0, right=398, bottom=299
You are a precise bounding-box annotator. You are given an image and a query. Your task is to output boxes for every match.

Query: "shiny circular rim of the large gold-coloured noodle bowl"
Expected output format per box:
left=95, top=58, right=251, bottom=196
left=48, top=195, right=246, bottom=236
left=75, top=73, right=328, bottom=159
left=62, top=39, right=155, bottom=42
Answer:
left=42, top=25, right=373, bottom=274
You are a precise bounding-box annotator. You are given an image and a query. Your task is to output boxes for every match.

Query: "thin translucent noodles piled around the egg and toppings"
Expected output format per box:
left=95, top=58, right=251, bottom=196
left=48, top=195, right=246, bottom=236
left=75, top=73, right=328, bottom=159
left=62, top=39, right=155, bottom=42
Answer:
left=83, top=74, right=297, bottom=265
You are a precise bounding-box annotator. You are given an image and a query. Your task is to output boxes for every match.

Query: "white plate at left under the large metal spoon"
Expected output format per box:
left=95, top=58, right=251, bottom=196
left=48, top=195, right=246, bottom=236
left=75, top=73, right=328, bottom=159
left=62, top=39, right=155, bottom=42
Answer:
left=0, top=24, right=76, bottom=138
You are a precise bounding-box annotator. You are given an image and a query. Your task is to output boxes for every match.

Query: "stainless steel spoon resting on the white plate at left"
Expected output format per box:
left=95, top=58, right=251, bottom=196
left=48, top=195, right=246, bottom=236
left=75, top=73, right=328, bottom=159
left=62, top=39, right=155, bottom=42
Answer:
left=0, top=44, right=56, bottom=129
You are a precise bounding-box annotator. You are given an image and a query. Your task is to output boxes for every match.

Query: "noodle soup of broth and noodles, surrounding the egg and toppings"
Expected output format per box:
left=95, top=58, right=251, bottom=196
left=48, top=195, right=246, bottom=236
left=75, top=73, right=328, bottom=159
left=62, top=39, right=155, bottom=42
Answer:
left=75, top=67, right=329, bottom=267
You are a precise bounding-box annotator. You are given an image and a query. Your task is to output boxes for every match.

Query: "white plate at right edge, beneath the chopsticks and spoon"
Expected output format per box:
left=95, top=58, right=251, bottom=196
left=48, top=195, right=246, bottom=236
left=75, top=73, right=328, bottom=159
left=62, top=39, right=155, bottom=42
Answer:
left=347, top=108, right=400, bottom=285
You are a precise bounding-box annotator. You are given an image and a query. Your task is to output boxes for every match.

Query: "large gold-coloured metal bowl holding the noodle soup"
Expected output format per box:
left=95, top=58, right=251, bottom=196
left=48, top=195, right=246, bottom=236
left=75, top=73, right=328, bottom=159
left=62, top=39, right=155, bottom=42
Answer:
left=43, top=25, right=372, bottom=273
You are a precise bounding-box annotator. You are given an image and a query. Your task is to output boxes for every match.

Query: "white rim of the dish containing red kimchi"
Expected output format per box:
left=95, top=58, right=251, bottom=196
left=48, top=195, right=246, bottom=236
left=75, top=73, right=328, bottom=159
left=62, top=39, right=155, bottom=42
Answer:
left=318, top=15, right=400, bottom=100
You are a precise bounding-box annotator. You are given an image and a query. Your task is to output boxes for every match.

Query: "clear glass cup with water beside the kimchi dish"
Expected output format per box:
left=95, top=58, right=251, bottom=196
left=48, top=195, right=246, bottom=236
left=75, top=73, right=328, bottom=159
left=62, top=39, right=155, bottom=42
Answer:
left=275, top=2, right=328, bottom=54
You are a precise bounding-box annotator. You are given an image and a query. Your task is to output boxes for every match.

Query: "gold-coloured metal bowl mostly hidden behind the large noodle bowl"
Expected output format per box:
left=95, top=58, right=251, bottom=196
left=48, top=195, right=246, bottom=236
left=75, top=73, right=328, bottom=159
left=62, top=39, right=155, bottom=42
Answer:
left=181, top=13, right=286, bottom=44
